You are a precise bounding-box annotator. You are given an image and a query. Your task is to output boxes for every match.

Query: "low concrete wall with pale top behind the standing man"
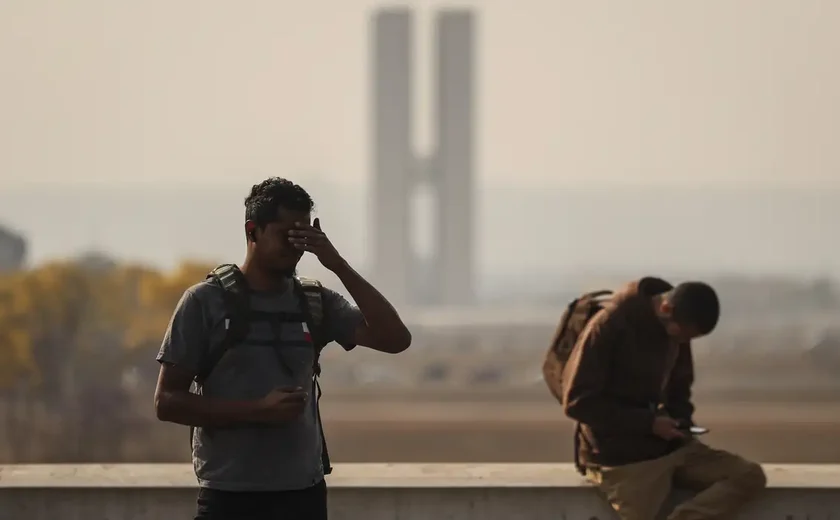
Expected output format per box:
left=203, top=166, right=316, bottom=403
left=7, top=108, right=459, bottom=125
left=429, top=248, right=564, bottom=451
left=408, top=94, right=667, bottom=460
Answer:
left=0, top=464, right=840, bottom=520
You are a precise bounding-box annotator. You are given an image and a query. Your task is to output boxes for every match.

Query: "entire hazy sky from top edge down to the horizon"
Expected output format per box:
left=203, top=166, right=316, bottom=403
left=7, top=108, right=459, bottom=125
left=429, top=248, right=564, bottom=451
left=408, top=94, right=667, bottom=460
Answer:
left=0, top=0, right=840, bottom=292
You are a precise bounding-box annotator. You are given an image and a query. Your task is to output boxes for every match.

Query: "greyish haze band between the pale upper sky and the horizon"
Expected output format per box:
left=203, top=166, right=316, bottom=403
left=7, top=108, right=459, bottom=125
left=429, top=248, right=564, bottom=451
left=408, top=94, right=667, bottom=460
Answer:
left=0, top=183, right=840, bottom=288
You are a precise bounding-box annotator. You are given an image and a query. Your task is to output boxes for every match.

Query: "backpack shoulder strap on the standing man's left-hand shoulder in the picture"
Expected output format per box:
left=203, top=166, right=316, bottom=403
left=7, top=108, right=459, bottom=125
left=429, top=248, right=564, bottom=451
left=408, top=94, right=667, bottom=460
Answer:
left=196, top=264, right=250, bottom=385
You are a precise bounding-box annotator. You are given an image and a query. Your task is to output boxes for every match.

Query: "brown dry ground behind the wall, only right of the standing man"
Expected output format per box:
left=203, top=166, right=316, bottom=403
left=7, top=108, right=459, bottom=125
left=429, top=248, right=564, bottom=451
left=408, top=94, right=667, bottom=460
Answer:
left=324, top=401, right=840, bottom=463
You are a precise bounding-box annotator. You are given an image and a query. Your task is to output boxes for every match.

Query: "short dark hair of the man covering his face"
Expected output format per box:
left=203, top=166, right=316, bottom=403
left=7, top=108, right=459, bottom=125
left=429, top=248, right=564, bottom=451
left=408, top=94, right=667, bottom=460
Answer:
left=245, top=177, right=315, bottom=229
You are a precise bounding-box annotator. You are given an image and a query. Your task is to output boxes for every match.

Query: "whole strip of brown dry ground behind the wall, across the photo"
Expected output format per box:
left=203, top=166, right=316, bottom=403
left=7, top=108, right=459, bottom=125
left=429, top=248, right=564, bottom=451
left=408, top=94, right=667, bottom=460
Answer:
left=18, top=387, right=840, bottom=464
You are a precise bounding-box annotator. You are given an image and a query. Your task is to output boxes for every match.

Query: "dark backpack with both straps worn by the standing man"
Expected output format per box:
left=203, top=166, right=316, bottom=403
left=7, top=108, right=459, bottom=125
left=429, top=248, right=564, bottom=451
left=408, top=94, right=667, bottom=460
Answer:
left=190, top=264, right=332, bottom=475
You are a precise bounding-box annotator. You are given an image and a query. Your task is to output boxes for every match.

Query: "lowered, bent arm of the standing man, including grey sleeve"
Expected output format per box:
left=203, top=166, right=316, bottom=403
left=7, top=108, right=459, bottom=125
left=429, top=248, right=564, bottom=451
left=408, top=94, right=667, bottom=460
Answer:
left=155, top=290, right=259, bottom=427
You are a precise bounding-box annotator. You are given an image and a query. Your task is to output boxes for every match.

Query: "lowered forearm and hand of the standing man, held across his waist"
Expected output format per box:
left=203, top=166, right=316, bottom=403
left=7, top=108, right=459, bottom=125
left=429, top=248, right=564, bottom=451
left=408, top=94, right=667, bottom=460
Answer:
left=155, top=392, right=259, bottom=428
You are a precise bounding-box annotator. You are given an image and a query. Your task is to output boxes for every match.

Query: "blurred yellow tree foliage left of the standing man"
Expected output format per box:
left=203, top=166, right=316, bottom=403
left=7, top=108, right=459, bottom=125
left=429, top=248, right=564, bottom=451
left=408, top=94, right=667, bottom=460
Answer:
left=0, top=262, right=217, bottom=393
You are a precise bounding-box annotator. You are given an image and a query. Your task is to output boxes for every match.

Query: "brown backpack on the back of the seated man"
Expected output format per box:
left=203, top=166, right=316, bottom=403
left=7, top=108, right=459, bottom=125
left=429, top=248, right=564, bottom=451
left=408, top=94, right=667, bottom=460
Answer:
left=543, top=290, right=613, bottom=475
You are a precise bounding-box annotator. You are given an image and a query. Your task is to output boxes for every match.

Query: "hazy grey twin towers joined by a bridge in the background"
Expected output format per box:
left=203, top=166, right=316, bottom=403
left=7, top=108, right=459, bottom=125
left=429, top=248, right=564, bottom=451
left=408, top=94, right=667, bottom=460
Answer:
left=371, top=9, right=475, bottom=306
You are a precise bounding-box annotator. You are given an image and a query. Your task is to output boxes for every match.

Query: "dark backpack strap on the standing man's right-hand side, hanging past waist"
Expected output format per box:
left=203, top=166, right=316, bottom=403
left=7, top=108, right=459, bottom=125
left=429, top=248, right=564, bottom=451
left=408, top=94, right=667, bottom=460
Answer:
left=295, top=277, right=332, bottom=475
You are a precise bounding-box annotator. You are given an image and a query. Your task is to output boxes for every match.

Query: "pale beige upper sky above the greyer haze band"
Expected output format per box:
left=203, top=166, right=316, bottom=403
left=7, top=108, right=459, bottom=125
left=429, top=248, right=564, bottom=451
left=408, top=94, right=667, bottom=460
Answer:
left=0, top=0, right=840, bottom=187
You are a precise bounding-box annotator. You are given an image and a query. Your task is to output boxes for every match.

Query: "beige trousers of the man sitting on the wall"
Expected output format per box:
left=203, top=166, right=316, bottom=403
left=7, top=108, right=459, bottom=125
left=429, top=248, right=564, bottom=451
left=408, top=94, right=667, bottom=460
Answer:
left=587, top=441, right=767, bottom=520
